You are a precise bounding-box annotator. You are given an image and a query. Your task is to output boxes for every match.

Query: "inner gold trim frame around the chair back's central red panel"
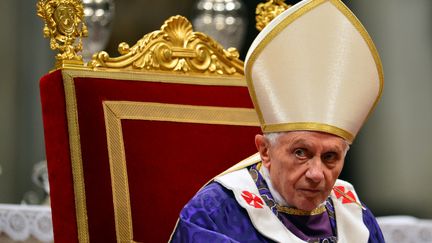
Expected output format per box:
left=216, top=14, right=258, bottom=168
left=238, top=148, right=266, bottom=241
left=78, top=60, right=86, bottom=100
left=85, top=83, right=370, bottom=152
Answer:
left=103, top=101, right=259, bottom=242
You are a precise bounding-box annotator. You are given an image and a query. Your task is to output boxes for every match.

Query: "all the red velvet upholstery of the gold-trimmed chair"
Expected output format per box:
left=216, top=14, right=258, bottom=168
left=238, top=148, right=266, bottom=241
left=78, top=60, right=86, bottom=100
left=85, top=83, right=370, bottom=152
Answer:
left=40, top=70, right=260, bottom=242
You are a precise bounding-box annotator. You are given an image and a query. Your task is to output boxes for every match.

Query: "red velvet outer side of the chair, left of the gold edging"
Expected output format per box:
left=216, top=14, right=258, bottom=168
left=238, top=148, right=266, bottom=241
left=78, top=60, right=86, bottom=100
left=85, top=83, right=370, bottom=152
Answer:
left=40, top=71, right=78, bottom=242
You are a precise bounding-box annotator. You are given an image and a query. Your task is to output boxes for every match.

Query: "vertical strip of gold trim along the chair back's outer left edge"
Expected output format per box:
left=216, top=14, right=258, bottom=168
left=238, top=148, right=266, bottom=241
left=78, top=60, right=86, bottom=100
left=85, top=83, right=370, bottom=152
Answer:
left=62, top=71, right=90, bottom=243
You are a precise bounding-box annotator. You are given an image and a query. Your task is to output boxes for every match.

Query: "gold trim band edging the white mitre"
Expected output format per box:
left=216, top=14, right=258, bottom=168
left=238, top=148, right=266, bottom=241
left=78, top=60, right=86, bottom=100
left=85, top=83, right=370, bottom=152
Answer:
left=245, top=0, right=384, bottom=143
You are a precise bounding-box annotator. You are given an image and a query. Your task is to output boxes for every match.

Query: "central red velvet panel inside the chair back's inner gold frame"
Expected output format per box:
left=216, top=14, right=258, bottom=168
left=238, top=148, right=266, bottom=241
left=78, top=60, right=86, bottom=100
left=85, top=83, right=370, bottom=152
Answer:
left=122, top=120, right=259, bottom=242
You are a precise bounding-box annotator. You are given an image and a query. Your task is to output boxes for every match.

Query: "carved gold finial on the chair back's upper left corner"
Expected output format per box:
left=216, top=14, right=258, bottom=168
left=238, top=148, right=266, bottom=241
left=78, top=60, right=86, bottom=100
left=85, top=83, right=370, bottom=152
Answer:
left=37, top=0, right=88, bottom=68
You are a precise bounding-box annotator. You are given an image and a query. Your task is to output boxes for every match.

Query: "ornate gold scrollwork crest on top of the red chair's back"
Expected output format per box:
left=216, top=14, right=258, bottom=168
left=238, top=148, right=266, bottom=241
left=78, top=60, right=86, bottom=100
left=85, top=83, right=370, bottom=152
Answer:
left=88, top=16, right=244, bottom=75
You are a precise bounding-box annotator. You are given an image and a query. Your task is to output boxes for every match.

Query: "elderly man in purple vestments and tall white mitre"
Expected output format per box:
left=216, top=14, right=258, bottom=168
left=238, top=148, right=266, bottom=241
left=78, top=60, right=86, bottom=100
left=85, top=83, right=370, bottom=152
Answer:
left=172, top=0, right=384, bottom=242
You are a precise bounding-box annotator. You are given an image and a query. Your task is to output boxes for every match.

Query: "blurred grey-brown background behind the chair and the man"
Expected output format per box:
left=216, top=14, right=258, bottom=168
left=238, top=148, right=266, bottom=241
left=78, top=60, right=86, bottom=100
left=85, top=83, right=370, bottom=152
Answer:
left=0, top=0, right=432, bottom=218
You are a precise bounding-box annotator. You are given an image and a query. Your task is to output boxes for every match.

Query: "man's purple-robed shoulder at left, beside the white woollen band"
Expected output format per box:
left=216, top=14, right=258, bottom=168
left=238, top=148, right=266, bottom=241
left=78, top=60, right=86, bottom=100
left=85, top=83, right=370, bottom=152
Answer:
left=173, top=178, right=269, bottom=242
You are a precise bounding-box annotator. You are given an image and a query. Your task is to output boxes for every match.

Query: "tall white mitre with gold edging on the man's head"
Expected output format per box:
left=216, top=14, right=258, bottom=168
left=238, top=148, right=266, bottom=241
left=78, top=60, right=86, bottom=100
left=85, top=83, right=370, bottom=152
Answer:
left=245, top=0, right=384, bottom=143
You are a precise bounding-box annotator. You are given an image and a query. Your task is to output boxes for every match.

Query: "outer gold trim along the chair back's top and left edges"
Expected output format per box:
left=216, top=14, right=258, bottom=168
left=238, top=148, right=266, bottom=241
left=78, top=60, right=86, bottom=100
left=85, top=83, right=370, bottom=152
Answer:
left=61, top=66, right=251, bottom=243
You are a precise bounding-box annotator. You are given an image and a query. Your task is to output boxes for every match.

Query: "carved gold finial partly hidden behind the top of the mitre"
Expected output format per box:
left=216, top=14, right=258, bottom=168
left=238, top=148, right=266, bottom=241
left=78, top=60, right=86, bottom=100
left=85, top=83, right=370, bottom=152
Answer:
left=255, top=0, right=291, bottom=31
